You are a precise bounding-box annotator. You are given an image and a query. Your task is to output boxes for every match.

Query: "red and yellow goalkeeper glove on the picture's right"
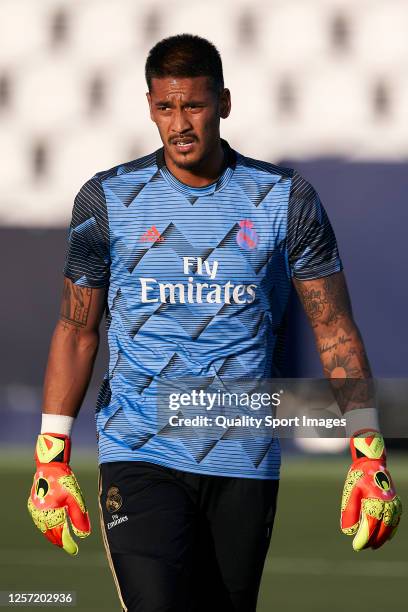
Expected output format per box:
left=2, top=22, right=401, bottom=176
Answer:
left=340, top=430, right=402, bottom=551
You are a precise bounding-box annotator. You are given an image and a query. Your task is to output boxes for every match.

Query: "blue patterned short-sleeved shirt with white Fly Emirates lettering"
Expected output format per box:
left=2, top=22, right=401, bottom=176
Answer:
left=64, top=141, right=342, bottom=479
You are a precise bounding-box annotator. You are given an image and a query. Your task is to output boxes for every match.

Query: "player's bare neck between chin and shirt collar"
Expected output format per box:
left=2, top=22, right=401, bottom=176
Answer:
left=164, top=140, right=226, bottom=187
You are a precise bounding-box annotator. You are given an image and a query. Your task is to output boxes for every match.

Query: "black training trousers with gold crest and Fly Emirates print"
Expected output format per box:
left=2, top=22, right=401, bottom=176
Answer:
left=99, top=461, right=279, bottom=612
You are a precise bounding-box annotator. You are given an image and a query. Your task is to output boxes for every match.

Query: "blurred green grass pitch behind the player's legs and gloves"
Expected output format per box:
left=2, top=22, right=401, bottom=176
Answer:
left=0, top=447, right=408, bottom=612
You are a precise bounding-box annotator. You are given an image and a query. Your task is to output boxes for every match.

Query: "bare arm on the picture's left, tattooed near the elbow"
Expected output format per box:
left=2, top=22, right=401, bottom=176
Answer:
left=42, top=277, right=106, bottom=417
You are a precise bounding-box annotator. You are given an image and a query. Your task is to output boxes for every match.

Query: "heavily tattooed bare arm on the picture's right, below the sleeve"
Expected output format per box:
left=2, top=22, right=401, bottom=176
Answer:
left=294, top=272, right=375, bottom=412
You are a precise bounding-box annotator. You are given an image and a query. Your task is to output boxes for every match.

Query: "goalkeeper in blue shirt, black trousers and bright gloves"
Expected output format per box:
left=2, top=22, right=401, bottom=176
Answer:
left=28, top=34, right=400, bottom=612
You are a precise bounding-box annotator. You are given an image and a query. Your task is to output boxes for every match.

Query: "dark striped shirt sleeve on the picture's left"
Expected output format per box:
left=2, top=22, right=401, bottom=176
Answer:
left=64, top=177, right=110, bottom=288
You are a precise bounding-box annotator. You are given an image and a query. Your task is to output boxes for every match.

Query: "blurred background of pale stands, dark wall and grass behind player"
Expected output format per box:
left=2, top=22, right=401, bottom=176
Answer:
left=0, top=0, right=408, bottom=612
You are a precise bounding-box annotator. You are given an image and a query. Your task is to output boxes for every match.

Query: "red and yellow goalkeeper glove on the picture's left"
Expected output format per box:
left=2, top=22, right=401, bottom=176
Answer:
left=27, top=433, right=91, bottom=555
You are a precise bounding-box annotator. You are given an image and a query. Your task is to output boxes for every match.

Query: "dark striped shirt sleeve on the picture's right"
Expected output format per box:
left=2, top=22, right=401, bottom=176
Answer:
left=286, top=172, right=343, bottom=280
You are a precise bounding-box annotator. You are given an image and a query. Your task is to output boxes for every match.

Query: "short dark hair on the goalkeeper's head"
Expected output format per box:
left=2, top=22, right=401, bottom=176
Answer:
left=145, top=34, right=224, bottom=91
